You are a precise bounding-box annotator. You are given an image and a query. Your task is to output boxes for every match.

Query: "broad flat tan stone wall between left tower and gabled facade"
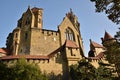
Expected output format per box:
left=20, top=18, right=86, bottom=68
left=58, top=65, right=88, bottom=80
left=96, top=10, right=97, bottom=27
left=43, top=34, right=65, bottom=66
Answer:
left=30, top=29, right=60, bottom=55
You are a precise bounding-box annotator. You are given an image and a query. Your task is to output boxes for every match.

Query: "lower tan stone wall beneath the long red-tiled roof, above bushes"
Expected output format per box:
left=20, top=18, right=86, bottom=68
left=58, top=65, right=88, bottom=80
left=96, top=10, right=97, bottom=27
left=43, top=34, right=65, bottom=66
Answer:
left=4, top=57, right=63, bottom=77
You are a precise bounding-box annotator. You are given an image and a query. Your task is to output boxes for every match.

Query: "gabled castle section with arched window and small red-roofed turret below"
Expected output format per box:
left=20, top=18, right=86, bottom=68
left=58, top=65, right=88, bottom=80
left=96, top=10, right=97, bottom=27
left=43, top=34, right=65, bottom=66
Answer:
left=59, top=9, right=84, bottom=65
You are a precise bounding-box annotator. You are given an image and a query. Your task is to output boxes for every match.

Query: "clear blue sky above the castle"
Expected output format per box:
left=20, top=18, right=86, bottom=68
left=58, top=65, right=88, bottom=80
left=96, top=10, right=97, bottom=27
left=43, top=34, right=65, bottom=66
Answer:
left=0, top=0, right=119, bottom=55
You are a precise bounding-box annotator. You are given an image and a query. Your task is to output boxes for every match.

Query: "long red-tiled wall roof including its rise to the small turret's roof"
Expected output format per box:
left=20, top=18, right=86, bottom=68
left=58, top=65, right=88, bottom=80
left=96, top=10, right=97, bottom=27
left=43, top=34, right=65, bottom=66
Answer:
left=0, top=40, right=78, bottom=60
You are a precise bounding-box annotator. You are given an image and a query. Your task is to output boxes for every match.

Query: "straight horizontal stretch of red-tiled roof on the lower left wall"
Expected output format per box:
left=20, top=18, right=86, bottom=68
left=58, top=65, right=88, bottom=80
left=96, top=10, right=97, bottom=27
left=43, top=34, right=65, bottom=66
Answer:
left=0, top=55, right=49, bottom=60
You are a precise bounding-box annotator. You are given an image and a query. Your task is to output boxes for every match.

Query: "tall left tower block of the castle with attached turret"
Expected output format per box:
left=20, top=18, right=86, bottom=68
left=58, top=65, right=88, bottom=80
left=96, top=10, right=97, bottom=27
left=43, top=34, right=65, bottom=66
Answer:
left=7, top=7, right=43, bottom=55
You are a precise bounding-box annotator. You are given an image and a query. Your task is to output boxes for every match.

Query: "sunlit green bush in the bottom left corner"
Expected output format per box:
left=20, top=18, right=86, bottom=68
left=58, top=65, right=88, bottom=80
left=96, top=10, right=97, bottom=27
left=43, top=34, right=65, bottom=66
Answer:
left=0, top=59, right=48, bottom=80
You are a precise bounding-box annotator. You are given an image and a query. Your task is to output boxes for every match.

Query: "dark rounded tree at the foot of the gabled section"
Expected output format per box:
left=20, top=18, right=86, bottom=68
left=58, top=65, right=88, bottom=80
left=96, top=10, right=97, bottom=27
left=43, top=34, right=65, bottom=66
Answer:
left=70, top=59, right=96, bottom=80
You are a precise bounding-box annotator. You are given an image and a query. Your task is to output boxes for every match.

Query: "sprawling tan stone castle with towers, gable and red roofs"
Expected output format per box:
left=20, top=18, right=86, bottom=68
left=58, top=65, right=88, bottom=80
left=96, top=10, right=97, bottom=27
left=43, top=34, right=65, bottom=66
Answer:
left=0, top=7, right=118, bottom=80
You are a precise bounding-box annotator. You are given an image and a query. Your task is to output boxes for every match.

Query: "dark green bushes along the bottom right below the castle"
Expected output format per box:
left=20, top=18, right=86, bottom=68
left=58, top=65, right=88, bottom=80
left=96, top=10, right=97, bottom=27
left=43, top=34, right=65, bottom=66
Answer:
left=70, top=59, right=117, bottom=80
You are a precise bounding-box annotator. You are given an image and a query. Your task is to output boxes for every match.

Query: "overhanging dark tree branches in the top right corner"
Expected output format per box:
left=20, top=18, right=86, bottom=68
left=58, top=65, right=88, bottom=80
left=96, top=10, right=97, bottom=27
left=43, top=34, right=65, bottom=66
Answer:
left=90, top=0, right=120, bottom=24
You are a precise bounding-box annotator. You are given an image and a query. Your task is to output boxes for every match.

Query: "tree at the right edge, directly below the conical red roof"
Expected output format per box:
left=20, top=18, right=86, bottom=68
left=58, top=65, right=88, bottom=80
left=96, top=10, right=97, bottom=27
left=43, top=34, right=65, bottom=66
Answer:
left=103, top=40, right=120, bottom=77
